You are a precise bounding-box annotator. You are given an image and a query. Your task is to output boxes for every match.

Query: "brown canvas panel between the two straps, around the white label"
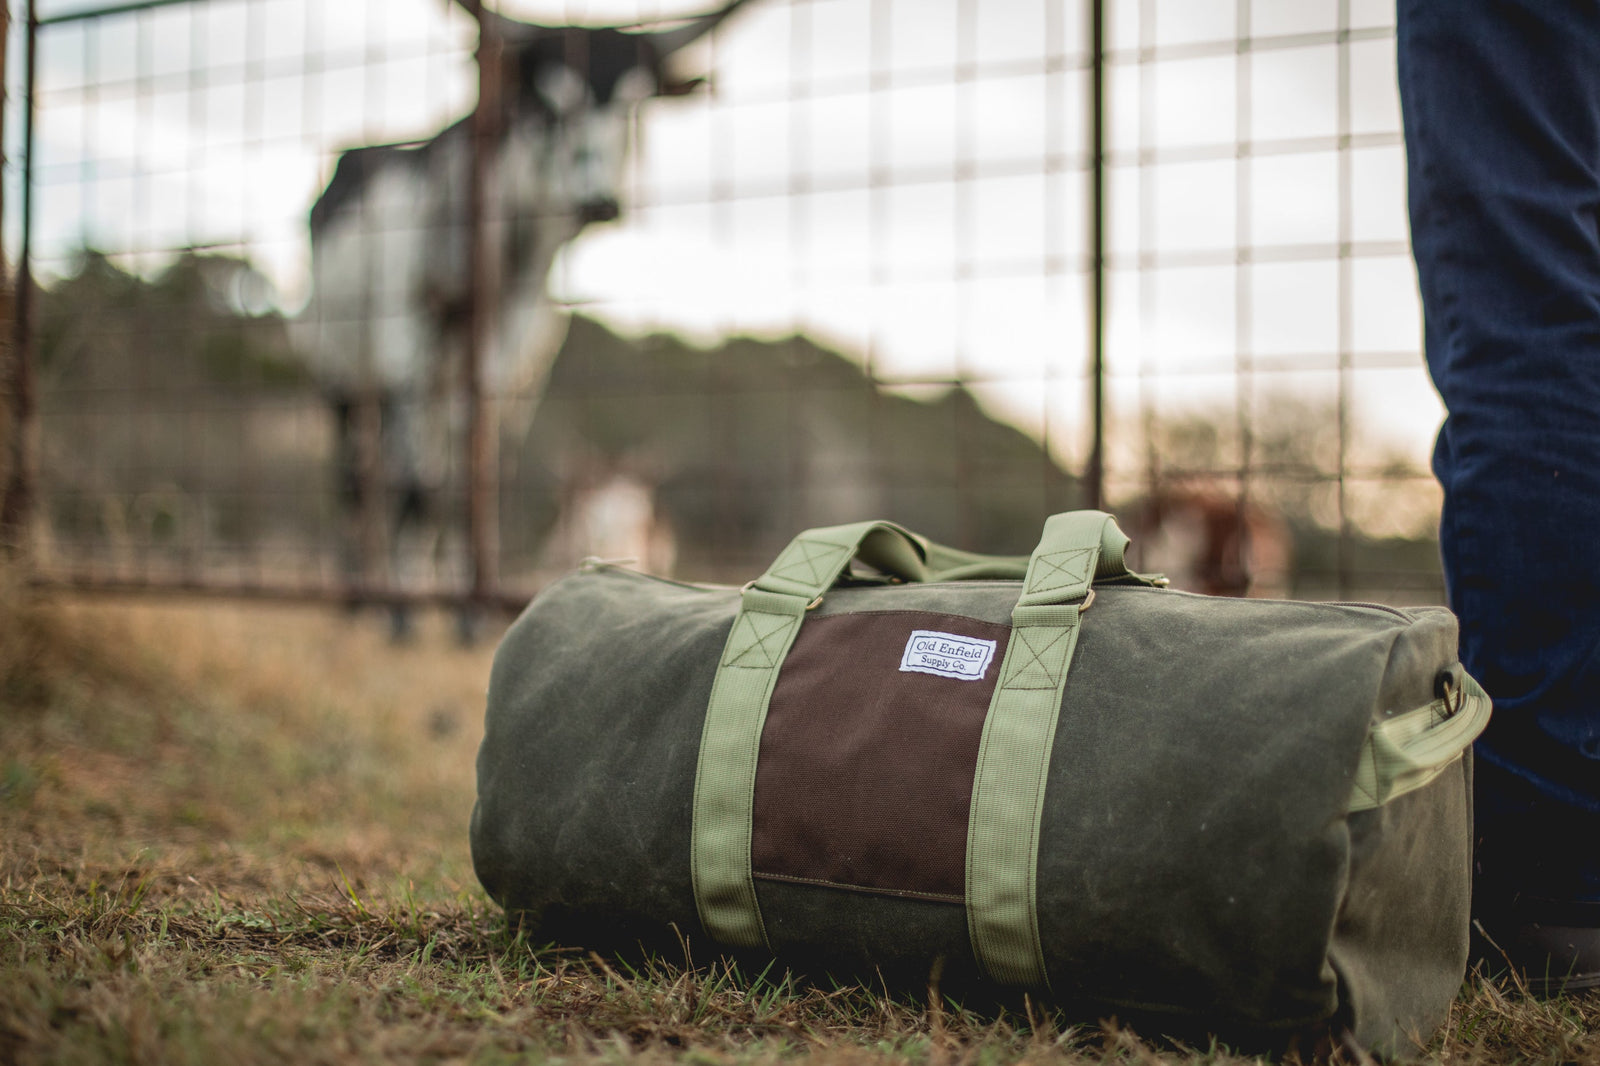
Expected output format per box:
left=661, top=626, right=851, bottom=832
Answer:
left=750, top=611, right=1011, bottom=903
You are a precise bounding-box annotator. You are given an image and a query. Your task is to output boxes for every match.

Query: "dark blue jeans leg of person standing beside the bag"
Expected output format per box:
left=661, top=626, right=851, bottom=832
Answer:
left=1398, top=0, right=1600, bottom=900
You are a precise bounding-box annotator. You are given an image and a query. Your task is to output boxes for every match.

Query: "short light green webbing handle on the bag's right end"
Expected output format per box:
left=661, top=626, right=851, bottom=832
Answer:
left=1350, top=666, right=1490, bottom=813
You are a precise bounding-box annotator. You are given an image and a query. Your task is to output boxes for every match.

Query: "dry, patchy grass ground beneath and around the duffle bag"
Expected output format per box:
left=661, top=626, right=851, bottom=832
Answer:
left=0, top=586, right=1600, bottom=1064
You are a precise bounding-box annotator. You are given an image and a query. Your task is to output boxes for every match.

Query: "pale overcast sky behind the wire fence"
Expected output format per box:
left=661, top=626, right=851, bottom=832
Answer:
left=8, top=0, right=1440, bottom=523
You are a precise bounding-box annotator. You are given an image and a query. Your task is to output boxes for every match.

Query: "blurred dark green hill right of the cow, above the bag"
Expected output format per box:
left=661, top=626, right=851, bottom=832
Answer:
left=504, top=317, right=1082, bottom=576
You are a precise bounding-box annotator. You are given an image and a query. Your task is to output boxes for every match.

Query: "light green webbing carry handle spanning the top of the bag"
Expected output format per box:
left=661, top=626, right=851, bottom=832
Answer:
left=750, top=511, right=1165, bottom=602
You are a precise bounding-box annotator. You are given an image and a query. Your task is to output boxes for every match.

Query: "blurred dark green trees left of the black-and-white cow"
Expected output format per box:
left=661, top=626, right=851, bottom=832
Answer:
left=35, top=250, right=326, bottom=565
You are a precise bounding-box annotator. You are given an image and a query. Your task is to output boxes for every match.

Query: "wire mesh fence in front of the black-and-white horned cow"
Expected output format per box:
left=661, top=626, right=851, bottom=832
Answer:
left=6, top=0, right=1442, bottom=614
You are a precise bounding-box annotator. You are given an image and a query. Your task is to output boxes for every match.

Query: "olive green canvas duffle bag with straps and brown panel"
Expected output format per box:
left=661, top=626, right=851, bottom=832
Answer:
left=472, top=511, right=1490, bottom=1052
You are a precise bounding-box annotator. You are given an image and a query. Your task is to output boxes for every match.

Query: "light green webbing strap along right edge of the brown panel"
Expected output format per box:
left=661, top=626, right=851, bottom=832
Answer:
left=966, top=511, right=1128, bottom=988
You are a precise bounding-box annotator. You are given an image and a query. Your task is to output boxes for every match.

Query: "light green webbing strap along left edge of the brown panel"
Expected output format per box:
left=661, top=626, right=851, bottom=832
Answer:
left=690, top=522, right=926, bottom=948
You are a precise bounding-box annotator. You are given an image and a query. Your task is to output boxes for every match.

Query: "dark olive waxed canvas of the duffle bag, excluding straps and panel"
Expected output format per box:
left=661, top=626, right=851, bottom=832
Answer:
left=472, top=568, right=1470, bottom=1052
